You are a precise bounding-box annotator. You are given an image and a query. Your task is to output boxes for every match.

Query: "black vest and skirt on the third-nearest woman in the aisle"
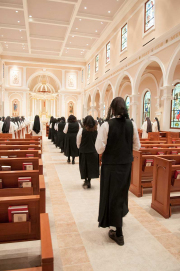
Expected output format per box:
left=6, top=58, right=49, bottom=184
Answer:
left=64, top=122, right=79, bottom=157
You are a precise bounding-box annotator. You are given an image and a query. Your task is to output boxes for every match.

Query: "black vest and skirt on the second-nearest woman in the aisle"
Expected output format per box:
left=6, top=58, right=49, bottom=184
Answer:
left=79, top=129, right=99, bottom=179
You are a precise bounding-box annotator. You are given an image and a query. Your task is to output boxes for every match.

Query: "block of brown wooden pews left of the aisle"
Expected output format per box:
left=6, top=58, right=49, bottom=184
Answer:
left=0, top=136, right=54, bottom=271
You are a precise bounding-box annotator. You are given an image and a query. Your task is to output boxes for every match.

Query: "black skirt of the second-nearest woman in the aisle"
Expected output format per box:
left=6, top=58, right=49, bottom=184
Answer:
left=79, top=152, right=99, bottom=179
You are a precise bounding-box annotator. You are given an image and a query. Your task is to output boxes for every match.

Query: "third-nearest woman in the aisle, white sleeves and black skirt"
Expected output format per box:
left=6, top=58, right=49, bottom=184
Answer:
left=63, top=115, right=81, bottom=164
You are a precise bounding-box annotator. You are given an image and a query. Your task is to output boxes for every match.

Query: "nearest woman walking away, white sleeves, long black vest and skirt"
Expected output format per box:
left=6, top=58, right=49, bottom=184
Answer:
left=95, top=97, right=140, bottom=246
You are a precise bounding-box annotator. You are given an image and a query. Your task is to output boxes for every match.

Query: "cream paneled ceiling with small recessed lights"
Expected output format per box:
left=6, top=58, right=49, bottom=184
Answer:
left=0, top=0, right=127, bottom=60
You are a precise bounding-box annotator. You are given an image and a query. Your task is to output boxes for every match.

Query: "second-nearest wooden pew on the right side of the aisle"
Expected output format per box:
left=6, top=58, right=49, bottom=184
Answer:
left=129, top=147, right=180, bottom=197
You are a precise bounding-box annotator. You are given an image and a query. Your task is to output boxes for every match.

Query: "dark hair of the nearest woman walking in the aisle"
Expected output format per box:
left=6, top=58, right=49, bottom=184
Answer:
left=106, top=97, right=129, bottom=120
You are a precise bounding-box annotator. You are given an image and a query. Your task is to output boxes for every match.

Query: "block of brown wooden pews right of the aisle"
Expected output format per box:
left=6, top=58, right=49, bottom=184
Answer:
left=130, top=133, right=180, bottom=221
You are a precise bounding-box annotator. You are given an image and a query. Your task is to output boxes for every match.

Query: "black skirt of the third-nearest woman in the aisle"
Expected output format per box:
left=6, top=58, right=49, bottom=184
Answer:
left=64, top=133, right=79, bottom=157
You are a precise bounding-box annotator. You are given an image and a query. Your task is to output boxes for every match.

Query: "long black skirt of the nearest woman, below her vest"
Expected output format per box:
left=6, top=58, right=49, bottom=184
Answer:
left=98, top=163, right=132, bottom=228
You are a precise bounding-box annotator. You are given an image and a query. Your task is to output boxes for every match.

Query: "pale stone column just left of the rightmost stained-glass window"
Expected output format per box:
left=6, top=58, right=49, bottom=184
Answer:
left=161, top=86, right=174, bottom=131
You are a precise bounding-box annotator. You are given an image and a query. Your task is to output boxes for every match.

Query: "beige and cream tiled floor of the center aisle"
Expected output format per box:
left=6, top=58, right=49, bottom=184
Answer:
left=43, top=137, right=180, bottom=271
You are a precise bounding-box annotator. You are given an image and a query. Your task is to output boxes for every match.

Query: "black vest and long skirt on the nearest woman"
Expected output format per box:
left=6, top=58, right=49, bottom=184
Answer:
left=98, top=118, right=133, bottom=228
